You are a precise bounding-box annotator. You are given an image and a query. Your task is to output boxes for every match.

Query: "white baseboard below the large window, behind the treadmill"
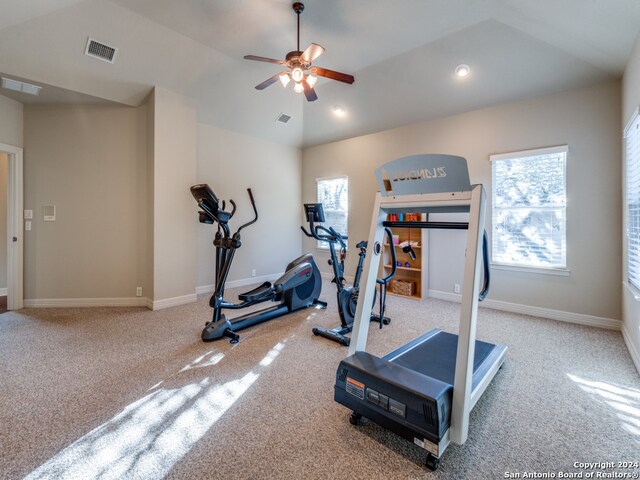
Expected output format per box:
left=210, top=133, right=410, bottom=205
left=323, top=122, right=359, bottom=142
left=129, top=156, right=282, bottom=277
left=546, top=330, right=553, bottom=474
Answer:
left=428, top=290, right=622, bottom=330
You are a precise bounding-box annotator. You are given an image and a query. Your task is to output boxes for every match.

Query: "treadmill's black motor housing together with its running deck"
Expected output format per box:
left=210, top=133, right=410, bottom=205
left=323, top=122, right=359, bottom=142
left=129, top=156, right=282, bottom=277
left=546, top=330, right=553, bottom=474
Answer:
left=334, top=329, right=494, bottom=444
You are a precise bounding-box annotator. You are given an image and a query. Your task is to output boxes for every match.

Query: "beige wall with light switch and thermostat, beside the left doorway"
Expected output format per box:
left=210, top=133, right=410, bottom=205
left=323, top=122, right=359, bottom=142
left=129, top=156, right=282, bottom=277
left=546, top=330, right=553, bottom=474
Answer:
left=24, top=106, right=146, bottom=300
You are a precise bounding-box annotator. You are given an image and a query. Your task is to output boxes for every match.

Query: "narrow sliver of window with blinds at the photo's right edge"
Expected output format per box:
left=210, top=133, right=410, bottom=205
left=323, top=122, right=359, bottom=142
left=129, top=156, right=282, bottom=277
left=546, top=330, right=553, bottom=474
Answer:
left=624, top=110, right=640, bottom=289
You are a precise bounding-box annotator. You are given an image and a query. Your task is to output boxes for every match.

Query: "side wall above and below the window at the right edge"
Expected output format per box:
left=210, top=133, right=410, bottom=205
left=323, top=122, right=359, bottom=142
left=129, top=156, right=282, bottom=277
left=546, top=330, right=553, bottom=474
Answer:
left=621, top=36, right=640, bottom=371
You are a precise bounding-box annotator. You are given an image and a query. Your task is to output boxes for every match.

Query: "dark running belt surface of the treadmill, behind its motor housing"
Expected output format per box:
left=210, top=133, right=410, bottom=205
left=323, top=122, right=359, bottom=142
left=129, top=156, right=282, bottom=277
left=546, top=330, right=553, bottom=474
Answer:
left=384, top=331, right=495, bottom=385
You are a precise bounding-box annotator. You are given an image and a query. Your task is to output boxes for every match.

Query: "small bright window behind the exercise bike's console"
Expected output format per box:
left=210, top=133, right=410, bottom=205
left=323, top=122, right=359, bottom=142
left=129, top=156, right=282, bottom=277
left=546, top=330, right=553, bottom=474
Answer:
left=316, top=177, right=349, bottom=248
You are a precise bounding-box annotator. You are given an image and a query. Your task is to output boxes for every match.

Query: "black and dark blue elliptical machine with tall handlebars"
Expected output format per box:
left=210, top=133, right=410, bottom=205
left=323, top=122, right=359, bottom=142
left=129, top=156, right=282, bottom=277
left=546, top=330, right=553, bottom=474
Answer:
left=191, top=183, right=327, bottom=343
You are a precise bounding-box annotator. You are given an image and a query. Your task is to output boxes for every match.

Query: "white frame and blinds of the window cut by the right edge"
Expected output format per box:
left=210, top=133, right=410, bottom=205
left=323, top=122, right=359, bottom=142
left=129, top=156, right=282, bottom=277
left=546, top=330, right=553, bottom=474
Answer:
left=623, top=107, right=640, bottom=300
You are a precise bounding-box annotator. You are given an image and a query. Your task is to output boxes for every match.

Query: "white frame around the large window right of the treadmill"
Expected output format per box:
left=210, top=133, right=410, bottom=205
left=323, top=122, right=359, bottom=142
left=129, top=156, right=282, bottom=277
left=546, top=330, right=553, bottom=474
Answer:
left=489, top=145, right=571, bottom=276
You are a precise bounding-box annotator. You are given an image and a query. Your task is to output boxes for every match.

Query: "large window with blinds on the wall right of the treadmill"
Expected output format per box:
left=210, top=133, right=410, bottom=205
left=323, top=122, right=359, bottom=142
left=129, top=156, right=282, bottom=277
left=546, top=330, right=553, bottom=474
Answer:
left=491, top=145, right=568, bottom=269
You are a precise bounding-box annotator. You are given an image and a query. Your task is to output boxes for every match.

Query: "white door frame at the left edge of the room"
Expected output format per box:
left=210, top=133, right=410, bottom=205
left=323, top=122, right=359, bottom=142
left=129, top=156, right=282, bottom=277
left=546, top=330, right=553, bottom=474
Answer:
left=0, top=143, right=24, bottom=310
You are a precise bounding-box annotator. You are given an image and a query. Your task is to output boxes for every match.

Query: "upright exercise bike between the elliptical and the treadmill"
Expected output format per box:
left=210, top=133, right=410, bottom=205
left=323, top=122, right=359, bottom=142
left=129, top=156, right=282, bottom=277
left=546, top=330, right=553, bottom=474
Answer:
left=300, top=203, right=396, bottom=346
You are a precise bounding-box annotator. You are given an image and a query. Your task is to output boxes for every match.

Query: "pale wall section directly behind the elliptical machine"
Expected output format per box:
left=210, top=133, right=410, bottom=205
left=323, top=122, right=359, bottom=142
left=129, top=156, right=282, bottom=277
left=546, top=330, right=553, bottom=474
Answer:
left=196, top=125, right=302, bottom=287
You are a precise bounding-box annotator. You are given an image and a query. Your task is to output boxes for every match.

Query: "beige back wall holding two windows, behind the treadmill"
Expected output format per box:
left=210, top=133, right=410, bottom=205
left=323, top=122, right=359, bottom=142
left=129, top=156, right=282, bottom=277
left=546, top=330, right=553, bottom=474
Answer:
left=302, top=82, right=621, bottom=319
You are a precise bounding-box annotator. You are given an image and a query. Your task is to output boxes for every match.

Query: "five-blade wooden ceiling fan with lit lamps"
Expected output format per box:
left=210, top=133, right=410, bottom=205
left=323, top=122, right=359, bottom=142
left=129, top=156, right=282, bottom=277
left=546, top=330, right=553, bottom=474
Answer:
left=244, top=2, right=354, bottom=102
